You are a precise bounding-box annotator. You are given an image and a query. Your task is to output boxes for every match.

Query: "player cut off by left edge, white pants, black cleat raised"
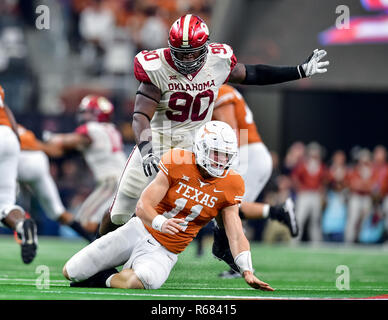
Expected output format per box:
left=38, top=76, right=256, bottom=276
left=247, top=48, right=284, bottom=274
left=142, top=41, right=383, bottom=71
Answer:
left=0, top=86, right=38, bottom=263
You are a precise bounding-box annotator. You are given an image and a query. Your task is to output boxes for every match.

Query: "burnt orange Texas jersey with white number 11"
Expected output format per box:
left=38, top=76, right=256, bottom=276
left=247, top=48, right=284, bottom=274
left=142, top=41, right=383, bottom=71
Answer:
left=145, top=149, right=245, bottom=253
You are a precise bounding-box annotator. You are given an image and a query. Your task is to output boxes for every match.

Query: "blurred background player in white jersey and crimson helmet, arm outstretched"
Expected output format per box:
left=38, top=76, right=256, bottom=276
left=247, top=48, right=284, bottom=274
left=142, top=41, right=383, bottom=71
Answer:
left=46, top=95, right=126, bottom=234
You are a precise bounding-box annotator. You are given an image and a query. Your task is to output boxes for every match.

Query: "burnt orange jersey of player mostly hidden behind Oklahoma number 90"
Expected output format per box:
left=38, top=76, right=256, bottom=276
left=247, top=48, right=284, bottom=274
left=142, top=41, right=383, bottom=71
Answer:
left=213, top=84, right=262, bottom=145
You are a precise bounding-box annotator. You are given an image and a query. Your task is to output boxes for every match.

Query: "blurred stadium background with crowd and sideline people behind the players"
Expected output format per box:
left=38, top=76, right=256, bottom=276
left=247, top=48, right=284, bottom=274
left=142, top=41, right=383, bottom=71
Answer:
left=0, top=0, right=388, bottom=243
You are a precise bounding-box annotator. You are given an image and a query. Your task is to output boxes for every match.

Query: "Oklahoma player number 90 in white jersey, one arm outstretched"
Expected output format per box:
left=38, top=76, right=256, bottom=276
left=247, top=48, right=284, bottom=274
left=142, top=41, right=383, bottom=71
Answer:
left=100, top=14, right=329, bottom=235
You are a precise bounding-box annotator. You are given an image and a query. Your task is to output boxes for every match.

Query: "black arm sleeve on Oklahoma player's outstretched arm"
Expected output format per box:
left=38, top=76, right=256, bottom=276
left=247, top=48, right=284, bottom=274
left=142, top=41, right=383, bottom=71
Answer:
left=241, top=64, right=304, bottom=85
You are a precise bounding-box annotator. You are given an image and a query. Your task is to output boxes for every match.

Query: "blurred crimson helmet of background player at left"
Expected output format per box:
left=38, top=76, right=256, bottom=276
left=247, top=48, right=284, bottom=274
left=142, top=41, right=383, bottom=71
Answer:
left=78, top=95, right=114, bottom=122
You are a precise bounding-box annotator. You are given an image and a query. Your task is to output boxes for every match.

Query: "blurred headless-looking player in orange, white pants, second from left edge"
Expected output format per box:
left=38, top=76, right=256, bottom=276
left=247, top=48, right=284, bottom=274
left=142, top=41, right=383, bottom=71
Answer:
left=17, top=124, right=95, bottom=241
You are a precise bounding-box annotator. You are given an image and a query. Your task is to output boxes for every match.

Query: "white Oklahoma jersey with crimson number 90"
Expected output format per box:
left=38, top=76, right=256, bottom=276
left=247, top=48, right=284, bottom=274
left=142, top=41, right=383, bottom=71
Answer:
left=134, top=43, right=236, bottom=154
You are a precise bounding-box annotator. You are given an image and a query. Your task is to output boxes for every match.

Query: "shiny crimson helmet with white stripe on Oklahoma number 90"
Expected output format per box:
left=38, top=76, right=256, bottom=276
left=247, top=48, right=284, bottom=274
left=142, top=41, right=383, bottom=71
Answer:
left=168, top=14, right=209, bottom=74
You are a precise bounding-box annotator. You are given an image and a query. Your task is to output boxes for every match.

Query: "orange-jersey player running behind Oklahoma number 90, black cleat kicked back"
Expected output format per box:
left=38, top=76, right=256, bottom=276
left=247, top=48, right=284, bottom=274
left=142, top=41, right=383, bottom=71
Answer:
left=212, top=84, right=298, bottom=278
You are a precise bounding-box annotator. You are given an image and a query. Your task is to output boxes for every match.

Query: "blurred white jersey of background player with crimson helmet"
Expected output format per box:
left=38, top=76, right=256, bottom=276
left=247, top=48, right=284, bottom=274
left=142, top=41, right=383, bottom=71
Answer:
left=76, top=121, right=127, bottom=182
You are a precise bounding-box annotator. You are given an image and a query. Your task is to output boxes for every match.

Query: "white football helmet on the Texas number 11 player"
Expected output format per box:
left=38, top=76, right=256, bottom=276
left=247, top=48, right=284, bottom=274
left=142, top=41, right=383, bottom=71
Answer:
left=194, top=121, right=238, bottom=178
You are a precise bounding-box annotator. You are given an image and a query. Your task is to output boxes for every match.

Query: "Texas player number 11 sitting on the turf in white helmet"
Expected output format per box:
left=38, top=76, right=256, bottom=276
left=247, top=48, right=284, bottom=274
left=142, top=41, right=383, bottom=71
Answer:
left=63, top=121, right=273, bottom=291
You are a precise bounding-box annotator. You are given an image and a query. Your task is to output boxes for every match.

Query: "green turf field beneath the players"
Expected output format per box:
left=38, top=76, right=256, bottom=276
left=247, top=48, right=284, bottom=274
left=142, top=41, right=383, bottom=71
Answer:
left=0, top=235, right=388, bottom=300
